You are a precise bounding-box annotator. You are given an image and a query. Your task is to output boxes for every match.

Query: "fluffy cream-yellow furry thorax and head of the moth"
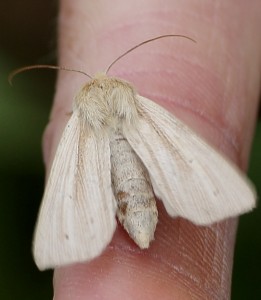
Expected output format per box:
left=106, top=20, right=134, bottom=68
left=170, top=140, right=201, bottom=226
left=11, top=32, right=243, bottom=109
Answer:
left=73, top=73, right=138, bottom=130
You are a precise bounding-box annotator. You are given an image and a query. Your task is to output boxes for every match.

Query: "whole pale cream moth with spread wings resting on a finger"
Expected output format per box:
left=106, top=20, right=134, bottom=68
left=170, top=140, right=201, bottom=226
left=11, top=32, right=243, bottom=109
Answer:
left=11, top=35, right=256, bottom=269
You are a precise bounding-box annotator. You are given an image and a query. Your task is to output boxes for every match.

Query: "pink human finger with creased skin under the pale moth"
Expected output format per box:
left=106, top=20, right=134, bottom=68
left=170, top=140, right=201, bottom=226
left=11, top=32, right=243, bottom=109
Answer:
left=39, top=0, right=261, bottom=300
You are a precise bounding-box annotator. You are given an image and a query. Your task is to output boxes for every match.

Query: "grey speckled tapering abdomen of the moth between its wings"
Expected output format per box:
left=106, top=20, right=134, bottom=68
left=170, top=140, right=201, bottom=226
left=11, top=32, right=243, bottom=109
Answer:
left=110, top=130, right=158, bottom=248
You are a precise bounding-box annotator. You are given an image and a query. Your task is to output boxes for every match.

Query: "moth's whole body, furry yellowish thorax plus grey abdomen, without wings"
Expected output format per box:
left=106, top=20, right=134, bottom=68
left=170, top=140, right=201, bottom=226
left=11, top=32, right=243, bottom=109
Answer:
left=74, top=74, right=158, bottom=248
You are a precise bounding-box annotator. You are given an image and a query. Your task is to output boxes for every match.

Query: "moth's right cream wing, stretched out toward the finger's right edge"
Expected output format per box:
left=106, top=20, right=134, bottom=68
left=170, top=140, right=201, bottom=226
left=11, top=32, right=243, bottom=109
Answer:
left=123, top=96, right=256, bottom=225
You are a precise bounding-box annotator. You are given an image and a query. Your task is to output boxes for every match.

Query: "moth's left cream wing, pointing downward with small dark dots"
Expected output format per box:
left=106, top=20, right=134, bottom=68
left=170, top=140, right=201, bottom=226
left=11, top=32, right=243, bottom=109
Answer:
left=33, top=113, right=116, bottom=269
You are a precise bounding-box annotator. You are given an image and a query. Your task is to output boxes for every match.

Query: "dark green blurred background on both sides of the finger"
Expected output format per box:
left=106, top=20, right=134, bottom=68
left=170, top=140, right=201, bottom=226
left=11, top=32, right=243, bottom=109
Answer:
left=0, top=0, right=261, bottom=300
